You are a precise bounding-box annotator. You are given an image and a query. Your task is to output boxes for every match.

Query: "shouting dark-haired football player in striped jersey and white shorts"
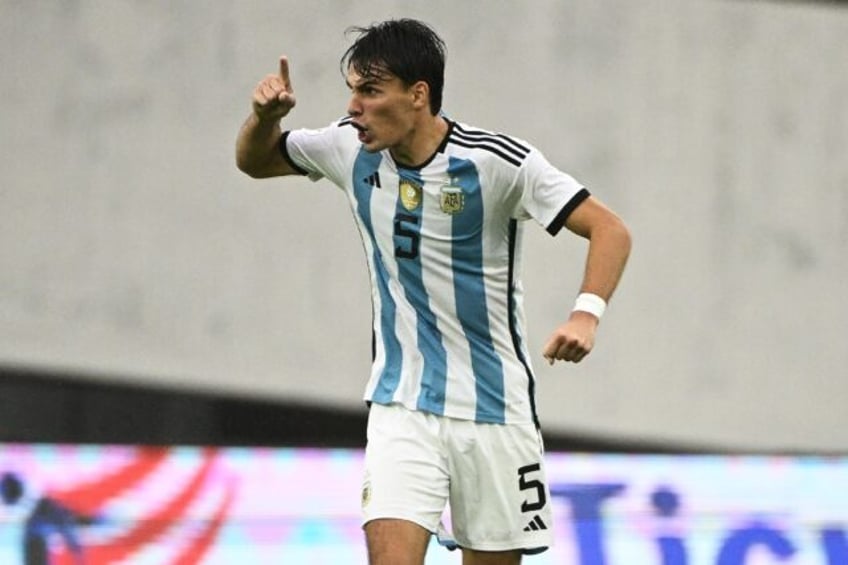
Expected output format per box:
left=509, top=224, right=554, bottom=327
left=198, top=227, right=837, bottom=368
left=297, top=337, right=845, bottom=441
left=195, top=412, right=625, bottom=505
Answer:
left=236, top=19, right=630, bottom=565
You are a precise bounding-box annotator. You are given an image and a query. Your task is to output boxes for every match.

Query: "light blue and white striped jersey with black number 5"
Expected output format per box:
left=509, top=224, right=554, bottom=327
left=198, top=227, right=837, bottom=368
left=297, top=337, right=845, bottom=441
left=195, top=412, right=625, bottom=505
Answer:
left=280, top=119, right=589, bottom=423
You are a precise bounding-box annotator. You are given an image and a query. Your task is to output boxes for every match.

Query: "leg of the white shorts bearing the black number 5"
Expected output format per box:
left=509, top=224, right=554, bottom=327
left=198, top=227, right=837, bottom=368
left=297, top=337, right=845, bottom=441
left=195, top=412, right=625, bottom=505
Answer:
left=448, top=422, right=553, bottom=552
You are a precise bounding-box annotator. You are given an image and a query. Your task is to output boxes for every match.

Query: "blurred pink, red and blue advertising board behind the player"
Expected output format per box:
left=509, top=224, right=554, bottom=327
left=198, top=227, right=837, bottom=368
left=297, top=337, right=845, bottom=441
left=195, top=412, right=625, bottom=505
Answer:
left=0, top=444, right=848, bottom=565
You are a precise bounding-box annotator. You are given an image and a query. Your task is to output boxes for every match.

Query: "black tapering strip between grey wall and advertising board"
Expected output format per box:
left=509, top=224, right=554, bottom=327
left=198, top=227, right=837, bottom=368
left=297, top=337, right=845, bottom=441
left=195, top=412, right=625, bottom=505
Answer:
left=0, top=367, right=717, bottom=453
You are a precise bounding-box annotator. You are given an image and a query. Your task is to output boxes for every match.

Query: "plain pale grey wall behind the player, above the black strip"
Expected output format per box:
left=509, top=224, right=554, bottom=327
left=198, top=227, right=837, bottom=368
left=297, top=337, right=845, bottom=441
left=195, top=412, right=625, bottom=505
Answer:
left=0, top=0, right=848, bottom=450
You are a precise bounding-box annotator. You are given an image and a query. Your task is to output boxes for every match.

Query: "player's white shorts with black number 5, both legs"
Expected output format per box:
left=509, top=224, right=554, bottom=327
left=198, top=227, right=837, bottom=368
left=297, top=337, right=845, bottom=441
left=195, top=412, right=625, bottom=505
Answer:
left=362, top=404, right=553, bottom=553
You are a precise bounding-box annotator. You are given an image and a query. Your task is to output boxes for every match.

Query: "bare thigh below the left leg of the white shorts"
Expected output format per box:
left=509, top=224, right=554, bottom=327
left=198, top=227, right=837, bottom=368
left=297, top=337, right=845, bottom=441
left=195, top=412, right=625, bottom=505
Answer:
left=365, top=518, right=431, bottom=565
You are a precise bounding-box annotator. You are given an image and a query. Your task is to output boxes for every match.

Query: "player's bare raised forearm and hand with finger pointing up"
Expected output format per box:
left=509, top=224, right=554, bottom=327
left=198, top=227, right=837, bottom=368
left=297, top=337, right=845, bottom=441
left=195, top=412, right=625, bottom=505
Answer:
left=236, top=56, right=300, bottom=178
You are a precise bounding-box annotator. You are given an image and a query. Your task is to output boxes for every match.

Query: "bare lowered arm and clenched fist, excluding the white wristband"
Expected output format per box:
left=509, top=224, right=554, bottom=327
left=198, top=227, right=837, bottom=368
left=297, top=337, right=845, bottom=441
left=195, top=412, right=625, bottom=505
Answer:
left=543, top=196, right=631, bottom=364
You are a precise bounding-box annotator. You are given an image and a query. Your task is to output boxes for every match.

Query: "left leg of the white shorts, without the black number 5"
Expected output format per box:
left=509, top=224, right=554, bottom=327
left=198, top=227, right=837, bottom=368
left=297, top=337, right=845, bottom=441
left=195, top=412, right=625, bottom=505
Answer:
left=362, top=404, right=449, bottom=534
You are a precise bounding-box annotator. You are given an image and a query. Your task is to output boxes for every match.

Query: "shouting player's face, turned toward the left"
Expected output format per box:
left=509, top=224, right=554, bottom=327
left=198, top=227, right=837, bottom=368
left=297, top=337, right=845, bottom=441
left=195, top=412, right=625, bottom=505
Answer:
left=347, top=67, right=420, bottom=153
